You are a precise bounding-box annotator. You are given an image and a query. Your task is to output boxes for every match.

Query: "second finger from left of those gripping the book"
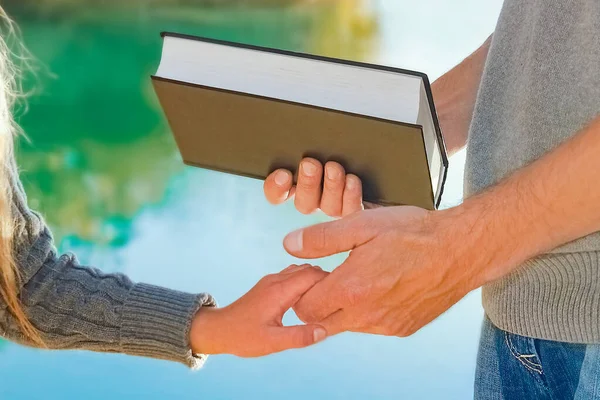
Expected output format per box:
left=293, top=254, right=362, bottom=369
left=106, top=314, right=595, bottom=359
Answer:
left=294, top=158, right=323, bottom=214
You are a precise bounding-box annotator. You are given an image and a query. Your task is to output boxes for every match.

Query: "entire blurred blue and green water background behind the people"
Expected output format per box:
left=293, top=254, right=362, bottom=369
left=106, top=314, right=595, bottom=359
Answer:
left=0, top=0, right=502, bottom=399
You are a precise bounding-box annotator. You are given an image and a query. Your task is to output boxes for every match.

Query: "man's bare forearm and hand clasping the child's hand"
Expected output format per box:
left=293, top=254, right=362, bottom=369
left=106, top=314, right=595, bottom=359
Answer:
left=284, top=118, right=600, bottom=336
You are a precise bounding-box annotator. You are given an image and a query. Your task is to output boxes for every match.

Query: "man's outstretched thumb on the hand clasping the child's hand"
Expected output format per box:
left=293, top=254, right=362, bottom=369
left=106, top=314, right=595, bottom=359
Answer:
left=283, top=211, right=377, bottom=258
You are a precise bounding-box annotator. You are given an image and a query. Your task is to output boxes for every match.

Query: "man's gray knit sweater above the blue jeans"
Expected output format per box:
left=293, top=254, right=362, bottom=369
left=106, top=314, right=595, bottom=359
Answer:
left=465, top=0, right=600, bottom=343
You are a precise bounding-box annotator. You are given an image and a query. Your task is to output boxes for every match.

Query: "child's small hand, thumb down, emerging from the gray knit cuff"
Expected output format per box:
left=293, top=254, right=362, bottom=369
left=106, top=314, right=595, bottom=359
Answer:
left=190, top=264, right=328, bottom=357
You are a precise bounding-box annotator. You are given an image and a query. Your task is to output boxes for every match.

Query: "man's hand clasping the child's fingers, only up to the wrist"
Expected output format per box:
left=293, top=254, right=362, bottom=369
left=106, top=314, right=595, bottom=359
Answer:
left=284, top=207, right=488, bottom=336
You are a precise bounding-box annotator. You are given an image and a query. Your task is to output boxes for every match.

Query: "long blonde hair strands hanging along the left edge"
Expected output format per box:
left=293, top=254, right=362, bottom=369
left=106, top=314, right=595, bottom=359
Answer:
left=0, top=6, right=43, bottom=346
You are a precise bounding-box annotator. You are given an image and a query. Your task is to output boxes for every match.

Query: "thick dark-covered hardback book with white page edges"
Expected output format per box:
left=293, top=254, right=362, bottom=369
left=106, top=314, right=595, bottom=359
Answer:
left=152, top=32, right=448, bottom=209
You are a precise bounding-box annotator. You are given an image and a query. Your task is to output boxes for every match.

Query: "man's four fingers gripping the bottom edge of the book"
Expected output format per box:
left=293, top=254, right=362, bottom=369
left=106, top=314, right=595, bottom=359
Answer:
left=264, top=158, right=363, bottom=217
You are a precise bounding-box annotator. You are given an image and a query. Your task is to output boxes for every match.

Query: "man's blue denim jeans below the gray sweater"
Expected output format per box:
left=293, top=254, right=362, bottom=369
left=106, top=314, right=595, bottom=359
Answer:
left=475, top=318, right=600, bottom=400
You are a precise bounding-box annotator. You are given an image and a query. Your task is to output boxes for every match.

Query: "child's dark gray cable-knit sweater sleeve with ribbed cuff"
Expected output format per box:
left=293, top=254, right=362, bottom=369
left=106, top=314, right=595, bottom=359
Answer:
left=0, top=155, right=215, bottom=368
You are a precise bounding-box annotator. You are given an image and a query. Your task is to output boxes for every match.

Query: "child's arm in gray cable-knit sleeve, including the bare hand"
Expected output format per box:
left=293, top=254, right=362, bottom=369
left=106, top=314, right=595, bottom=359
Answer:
left=0, top=158, right=326, bottom=367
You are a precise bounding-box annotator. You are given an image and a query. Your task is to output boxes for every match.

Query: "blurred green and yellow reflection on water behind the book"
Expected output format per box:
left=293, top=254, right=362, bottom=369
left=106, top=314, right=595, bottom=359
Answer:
left=8, top=0, right=376, bottom=247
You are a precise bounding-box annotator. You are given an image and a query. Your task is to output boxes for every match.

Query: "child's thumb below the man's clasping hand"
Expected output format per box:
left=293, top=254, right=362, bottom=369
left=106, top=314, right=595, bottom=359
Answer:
left=267, top=325, right=327, bottom=353
